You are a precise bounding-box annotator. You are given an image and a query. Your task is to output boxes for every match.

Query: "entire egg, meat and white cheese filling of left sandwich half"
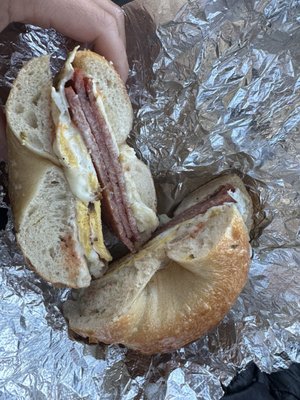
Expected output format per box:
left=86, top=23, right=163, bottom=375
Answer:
left=52, top=48, right=158, bottom=276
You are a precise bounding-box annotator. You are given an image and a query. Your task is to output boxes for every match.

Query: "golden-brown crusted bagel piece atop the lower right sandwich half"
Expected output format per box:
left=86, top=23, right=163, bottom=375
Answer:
left=64, top=204, right=250, bottom=354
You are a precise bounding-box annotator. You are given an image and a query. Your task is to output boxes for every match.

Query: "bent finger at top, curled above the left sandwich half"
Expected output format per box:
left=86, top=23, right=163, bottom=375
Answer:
left=14, top=0, right=128, bottom=81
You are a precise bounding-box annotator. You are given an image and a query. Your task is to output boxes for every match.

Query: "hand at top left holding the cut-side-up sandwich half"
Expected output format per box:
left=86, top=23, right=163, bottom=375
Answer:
left=0, top=0, right=128, bottom=161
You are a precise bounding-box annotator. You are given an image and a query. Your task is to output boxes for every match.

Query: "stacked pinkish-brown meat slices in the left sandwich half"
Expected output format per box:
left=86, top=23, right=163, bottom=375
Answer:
left=65, top=70, right=139, bottom=251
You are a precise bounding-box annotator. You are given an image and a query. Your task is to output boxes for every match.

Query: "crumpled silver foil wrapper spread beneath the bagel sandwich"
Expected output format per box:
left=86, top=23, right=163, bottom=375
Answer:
left=0, top=0, right=300, bottom=400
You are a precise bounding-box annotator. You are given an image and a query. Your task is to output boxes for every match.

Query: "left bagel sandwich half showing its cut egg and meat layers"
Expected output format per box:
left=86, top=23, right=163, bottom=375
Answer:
left=6, top=48, right=158, bottom=288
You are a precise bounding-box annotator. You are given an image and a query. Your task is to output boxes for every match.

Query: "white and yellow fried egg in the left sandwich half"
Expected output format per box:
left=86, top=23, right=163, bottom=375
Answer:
left=52, top=48, right=111, bottom=271
